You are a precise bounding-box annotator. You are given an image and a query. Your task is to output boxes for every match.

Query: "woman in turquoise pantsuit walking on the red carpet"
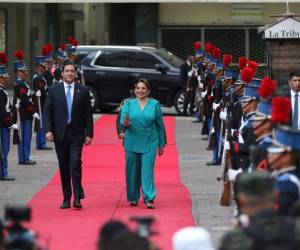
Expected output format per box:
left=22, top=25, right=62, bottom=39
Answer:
left=120, top=79, right=166, bottom=208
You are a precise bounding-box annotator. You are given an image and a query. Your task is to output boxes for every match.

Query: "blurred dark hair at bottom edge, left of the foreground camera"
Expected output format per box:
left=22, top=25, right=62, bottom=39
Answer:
left=98, top=220, right=129, bottom=250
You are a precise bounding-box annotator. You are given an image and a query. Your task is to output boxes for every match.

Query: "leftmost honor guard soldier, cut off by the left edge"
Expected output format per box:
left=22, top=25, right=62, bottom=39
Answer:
left=0, top=52, right=17, bottom=181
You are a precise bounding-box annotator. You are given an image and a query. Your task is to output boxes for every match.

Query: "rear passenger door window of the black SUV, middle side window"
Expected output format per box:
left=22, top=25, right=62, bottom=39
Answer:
left=95, top=51, right=128, bottom=67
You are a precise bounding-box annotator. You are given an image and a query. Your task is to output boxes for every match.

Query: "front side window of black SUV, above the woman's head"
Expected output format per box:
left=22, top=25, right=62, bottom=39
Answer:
left=129, top=52, right=161, bottom=69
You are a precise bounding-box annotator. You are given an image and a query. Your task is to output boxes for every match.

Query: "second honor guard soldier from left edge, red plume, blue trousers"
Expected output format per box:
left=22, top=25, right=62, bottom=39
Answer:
left=13, top=50, right=39, bottom=165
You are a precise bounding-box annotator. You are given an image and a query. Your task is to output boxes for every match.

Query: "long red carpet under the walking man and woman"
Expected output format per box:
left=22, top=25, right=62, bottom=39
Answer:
left=29, top=115, right=194, bottom=250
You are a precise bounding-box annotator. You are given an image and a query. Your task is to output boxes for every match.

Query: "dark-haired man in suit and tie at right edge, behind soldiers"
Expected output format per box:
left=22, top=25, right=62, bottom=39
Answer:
left=288, top=71, right=300, bottom=129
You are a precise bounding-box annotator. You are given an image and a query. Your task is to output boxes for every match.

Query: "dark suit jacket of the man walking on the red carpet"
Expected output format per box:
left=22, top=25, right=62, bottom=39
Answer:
left=44, top=82, right=93, bottom=142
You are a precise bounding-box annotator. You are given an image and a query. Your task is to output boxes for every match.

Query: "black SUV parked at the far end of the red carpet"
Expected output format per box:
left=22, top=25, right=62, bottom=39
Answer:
left=77, top=46, right=184, bottom=113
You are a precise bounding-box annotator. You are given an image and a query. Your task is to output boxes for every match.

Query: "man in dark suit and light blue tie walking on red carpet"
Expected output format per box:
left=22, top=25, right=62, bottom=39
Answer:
left=45, top=61, right=93, bottom=209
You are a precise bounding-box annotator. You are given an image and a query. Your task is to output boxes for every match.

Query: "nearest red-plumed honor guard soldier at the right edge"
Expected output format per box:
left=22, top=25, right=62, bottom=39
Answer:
left=267, top=97, right=300, bottom=214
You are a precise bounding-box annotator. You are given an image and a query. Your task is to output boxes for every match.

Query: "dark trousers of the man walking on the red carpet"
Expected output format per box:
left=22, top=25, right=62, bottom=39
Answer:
left=55, top=126, right=84, bottom=200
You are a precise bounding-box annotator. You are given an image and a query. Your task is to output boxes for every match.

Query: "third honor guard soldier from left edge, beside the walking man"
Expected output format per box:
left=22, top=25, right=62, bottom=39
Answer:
left=32, top=56, right=52, bottom=150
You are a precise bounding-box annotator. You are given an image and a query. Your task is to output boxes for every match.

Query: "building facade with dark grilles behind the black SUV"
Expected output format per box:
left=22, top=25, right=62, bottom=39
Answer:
left=0, top=0, right=300, bottom=81
